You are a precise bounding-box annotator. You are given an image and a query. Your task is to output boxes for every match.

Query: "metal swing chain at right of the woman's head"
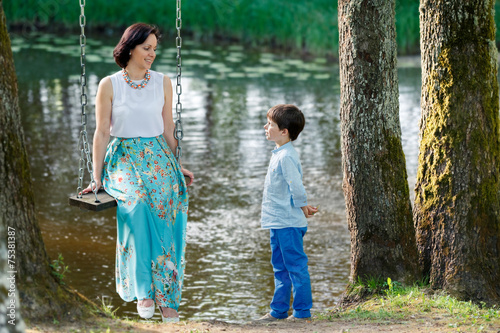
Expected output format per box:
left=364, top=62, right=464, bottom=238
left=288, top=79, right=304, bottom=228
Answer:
left=174, top=0, right=184, bottom=163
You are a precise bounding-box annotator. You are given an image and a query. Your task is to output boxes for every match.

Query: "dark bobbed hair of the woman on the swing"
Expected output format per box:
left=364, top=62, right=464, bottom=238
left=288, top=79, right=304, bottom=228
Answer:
left=113, top=23, right=161, bottom=68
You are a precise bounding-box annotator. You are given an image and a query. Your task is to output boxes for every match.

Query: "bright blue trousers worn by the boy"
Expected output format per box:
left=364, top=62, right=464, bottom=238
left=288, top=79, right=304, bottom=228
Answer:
left=270, top=227, right=312, bottom=319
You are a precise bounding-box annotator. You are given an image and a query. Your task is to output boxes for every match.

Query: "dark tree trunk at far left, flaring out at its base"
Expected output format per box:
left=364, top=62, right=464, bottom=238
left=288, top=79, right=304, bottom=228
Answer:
left=0, top=0, right=96, bottom=320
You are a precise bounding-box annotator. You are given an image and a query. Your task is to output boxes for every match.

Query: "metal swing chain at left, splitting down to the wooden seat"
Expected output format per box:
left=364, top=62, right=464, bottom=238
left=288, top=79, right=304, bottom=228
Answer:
left=76, top=0, right=99, bottom=202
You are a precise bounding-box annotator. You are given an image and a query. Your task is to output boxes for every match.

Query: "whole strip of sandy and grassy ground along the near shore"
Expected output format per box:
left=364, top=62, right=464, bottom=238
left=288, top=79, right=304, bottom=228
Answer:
left=27, top=281, right=500, bottom=333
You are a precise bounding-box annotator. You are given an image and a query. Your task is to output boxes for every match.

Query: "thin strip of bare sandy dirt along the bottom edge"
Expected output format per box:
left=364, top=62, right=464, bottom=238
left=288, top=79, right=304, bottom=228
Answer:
left=26, top=314, right=500, bottom=333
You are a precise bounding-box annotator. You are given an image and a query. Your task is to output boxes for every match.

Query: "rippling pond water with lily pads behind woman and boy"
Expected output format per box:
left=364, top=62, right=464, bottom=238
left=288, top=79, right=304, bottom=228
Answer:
left=12, top=31, right=420, bottom=322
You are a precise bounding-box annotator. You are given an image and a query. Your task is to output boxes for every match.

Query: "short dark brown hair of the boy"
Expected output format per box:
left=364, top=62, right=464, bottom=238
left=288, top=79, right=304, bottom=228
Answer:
left=267, top=104, right=306, bottom=141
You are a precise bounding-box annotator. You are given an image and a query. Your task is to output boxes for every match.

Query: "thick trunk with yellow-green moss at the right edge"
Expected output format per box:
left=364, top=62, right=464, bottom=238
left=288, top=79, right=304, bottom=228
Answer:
left=414, top=0, right=500, bottom=303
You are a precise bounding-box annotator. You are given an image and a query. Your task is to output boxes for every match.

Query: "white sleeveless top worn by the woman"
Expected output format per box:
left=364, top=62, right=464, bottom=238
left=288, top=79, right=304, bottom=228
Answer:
left=110, top=70, right=165, bottom=138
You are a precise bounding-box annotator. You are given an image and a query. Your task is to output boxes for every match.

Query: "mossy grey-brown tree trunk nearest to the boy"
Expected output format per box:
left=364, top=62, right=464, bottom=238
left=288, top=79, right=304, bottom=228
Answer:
left=338, top=0, right=420, bottom=290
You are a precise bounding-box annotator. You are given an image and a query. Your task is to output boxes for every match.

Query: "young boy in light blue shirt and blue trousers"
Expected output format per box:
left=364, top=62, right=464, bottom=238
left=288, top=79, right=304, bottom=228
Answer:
left=258, top=104, right=318, bottom=322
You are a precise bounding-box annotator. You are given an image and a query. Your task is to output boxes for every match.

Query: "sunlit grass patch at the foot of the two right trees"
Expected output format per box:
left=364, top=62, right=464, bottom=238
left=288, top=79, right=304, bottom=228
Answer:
left=318, top=278, right=500, bottom=332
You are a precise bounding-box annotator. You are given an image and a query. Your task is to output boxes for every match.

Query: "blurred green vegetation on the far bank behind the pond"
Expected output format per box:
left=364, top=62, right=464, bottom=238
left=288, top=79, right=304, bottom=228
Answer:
left=4, top=0, right=500, bottom=58
